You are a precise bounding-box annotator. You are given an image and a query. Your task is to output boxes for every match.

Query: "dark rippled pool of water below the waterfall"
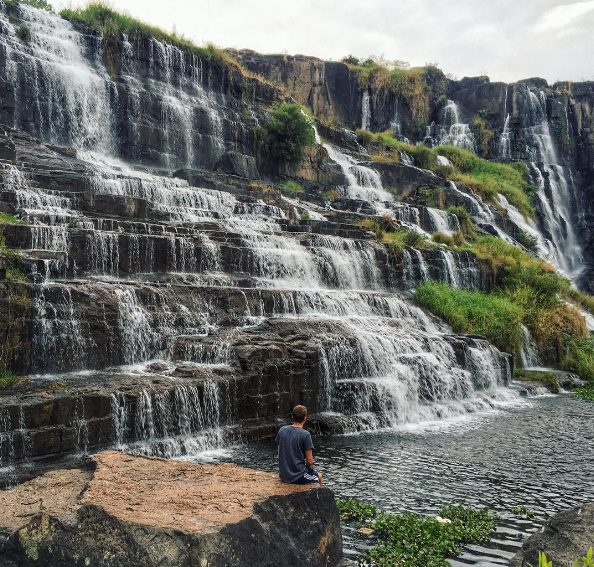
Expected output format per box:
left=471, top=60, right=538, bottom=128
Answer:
left=207, top=396, right=594, bottom=566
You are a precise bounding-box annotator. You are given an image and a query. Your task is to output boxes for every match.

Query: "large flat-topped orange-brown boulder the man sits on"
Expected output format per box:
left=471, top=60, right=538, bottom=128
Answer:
left=0, top=451, right=342, bottom=567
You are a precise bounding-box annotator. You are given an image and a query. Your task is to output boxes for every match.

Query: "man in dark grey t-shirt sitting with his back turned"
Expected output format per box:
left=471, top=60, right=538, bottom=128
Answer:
left=276, top=406, right=322, bottom=485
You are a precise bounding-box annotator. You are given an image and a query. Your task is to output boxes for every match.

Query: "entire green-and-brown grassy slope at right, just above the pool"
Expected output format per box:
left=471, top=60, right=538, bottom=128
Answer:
left=415, top=244, right=594, bottom=368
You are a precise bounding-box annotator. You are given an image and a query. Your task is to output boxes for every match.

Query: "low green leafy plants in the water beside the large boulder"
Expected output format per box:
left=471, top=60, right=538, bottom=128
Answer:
left=337, top=499, right=496, bottom=567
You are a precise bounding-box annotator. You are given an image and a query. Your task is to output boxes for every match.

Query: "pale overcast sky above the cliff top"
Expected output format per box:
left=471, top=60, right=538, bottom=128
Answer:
left=54, top=0, right=594, bottom=82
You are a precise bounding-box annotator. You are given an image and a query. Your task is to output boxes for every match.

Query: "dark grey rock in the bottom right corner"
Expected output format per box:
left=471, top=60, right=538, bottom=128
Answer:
left=510, top=504, right=594, bottom=567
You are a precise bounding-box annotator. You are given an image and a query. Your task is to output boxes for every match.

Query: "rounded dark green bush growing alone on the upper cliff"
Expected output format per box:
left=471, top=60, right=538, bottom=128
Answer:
left=264, top=102, right=316, bottom=165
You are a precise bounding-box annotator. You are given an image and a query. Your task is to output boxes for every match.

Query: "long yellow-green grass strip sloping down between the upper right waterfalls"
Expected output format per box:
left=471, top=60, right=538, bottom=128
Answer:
left=357, top=130, right=536, bottom=219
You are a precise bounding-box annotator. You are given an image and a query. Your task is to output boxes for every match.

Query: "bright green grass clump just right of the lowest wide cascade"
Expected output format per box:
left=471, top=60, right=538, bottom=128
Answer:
left=415, top=282, right=523, bottom=353
